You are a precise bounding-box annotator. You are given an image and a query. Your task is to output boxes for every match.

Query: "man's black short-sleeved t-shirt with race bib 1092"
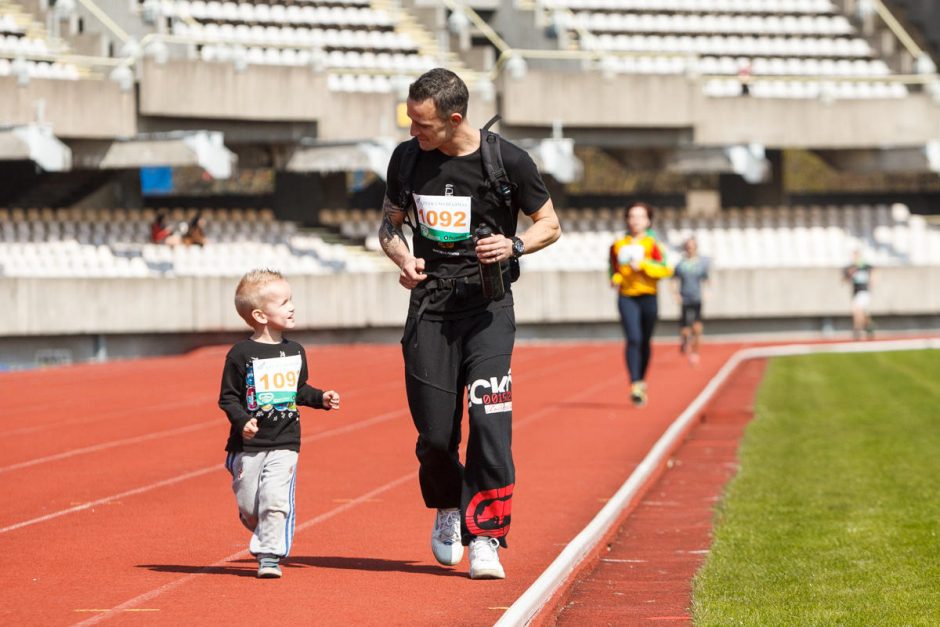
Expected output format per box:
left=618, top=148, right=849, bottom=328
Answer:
left=385, top=137, right=549, bottom=319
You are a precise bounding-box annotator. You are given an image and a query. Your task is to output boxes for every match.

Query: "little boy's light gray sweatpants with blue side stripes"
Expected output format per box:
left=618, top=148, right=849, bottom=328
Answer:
left=225, top=449, right=297, bottom=557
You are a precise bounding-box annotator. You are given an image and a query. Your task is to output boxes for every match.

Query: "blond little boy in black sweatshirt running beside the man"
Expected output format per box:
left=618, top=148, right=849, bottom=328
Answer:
left=219, top=270, right=340, bottom=578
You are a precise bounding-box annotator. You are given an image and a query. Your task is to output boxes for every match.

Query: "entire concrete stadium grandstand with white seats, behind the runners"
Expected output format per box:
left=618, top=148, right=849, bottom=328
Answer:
left=0, top=0, right=940, bottom=366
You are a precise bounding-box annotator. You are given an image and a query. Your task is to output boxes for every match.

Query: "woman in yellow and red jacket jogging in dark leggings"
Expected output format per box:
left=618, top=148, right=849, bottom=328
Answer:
left=610, top=202, right=672, bottom=407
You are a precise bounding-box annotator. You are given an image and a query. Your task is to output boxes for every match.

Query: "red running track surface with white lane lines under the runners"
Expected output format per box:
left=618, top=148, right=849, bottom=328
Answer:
left=0, top=343, right=739, bottom=625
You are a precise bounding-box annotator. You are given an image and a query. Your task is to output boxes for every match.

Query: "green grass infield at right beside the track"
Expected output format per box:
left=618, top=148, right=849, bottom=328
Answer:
left=692, top=351, right=940, bottom=625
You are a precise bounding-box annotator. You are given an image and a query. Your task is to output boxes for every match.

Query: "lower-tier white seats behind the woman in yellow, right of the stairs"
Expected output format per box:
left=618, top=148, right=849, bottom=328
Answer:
left=323, top=204, right=940, bottom=271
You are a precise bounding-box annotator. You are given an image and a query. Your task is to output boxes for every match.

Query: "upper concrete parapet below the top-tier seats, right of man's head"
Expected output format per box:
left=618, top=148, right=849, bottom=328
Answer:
left=500, top=70, right=940, bottom=148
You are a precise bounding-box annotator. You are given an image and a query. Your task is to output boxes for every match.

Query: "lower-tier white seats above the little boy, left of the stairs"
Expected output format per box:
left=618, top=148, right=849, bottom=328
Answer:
left=0, top=209, right=389, bottom=278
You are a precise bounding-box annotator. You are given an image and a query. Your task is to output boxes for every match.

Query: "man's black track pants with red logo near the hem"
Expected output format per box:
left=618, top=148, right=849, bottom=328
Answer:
left=402, top=307, right=516, bottom=546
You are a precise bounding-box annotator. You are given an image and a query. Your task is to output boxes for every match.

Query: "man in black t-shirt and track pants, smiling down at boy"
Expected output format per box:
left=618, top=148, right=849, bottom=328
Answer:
left=379, top=68, right=561, bottom=579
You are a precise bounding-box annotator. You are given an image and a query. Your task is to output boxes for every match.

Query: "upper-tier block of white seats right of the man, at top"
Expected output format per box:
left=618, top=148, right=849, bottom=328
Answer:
left=540, top=0, right=907, bottom=99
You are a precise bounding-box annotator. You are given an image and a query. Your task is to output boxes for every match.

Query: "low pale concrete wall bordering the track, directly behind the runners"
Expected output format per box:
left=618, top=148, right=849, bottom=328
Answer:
left=0, top=267, right=940, bottom=338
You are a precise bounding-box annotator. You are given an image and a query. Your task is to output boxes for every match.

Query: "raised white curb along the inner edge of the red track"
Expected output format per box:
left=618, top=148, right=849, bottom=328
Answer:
left=494, top=338, right=940, bottom=627
